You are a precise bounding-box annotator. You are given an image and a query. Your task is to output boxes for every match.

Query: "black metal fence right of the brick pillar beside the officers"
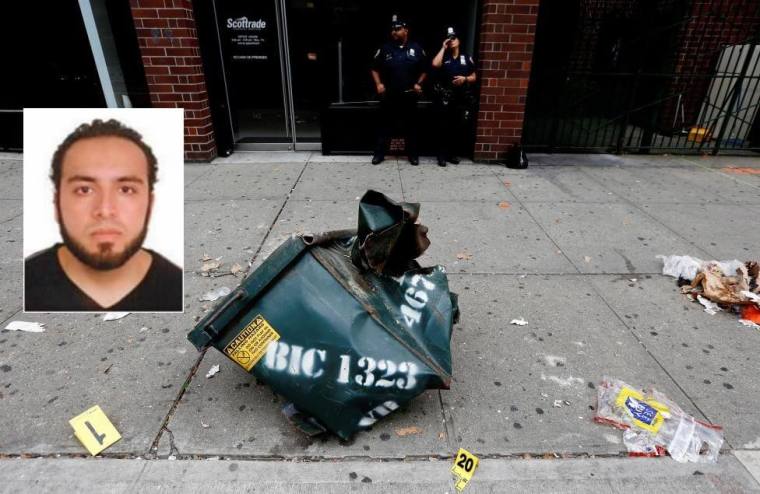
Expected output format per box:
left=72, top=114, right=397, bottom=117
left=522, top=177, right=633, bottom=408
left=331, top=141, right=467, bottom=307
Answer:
left=523, top=0, right=760, bottom=154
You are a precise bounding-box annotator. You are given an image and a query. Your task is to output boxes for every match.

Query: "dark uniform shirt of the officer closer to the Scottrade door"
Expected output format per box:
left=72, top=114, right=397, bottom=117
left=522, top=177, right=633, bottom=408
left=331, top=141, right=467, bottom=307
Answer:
left=372, top=41, right=427, bottom=92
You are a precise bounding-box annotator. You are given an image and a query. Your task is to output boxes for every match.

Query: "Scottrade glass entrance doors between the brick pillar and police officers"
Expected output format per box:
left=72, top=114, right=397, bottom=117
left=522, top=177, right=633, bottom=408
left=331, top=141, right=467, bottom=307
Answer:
left=214, top=0, right=324, bottom=150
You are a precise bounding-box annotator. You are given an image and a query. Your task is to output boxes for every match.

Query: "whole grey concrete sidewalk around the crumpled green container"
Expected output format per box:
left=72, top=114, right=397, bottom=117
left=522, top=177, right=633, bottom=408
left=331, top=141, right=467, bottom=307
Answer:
left=0, top=153, right=760, bottom=492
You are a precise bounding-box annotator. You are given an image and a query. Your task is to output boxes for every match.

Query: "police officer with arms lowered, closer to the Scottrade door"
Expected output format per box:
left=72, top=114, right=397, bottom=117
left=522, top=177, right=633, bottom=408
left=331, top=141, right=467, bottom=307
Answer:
left=372, top=15, right=427, bottom=166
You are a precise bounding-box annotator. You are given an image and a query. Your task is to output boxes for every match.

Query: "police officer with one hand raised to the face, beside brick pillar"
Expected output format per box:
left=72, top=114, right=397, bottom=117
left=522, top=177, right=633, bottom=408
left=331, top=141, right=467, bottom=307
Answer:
left=432, top=27, right=478, bottom=166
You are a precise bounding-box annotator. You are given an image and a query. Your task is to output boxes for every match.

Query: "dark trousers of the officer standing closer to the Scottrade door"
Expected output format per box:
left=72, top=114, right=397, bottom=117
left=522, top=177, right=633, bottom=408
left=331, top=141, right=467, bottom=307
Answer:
left=375, top=92, right=419, bottom=158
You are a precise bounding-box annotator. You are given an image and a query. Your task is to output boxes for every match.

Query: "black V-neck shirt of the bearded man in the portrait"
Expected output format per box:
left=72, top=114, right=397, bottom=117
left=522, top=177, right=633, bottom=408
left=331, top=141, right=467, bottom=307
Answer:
left=24, top=243, right=182, bottom=312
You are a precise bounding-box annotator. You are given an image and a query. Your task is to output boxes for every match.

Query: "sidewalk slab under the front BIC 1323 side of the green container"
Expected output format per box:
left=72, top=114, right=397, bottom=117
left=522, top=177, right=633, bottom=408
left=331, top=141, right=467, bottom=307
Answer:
left=168, top=349, right=451, bottom=458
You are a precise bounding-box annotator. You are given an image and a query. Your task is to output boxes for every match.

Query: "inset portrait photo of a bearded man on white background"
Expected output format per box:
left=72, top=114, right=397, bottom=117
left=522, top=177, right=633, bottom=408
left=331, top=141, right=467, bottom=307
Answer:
left=23, top=108, right=184, bottom=312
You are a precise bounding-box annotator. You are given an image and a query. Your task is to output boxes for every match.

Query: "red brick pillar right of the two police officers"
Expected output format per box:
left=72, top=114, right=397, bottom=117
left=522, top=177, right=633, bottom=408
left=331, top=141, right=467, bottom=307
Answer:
left=475, top=0, right=539, bottom=161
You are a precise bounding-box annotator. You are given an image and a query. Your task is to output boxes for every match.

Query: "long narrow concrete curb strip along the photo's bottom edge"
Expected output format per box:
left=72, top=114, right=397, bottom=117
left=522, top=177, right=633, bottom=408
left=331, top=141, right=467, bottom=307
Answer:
left=0, top=455, right=758, bottom=494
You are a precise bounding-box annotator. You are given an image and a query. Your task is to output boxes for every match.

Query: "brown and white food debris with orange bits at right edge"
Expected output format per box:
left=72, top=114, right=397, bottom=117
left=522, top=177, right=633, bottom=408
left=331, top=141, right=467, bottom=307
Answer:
left=657, top=255, right=760, bottom=323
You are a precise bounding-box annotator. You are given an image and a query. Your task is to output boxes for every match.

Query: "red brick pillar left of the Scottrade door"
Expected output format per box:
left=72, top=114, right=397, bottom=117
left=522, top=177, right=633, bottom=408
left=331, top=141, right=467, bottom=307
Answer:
left=130, top=0, right=216, bottom=161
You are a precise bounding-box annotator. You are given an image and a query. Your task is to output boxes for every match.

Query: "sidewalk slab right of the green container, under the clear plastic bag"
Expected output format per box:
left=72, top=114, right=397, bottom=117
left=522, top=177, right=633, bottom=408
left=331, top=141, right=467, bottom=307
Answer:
left=441, top=275, right=703, bottom=454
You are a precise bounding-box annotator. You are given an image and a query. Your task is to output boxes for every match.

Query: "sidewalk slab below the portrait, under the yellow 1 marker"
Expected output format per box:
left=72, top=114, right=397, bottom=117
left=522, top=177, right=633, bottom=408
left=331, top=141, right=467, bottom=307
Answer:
left=0, top=313, right=198, bottom=454
